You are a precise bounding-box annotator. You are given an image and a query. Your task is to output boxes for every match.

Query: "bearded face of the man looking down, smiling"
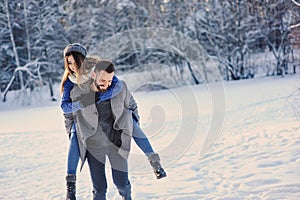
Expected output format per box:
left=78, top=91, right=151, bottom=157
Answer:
left=92, top=70, right=114, bottom=92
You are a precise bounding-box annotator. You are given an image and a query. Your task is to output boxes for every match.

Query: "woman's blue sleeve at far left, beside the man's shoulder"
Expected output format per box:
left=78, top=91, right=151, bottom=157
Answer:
left=60, top=79, right=81, bottom=114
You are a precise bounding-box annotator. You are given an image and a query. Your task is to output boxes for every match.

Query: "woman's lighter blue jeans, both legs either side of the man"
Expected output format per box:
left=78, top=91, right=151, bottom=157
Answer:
left=67, top=120, right=154, bottom=174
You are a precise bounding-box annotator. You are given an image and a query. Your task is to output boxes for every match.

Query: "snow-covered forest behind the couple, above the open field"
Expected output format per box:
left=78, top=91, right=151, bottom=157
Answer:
left=0, top=0, right=300, bottom=103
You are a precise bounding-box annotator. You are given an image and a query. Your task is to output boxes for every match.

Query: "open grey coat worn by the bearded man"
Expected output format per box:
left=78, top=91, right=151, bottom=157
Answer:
left=71, top=79, right=138, bottom=169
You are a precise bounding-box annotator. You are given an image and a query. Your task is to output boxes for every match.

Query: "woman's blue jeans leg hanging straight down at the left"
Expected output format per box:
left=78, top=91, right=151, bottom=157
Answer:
left=67, top=125, right=80, bottom=174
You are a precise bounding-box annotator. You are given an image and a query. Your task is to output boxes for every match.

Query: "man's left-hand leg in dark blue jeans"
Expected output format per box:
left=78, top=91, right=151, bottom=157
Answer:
left=87, top=152, right=107, bottom=200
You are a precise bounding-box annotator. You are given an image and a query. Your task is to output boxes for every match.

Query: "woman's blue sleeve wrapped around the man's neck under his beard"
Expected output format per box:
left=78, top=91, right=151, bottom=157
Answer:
left=96, top=76, right=123, bottom=103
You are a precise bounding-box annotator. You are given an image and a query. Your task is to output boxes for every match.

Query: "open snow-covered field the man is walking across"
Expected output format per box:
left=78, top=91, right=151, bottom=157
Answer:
left=0, top=76, right=300, bottom=200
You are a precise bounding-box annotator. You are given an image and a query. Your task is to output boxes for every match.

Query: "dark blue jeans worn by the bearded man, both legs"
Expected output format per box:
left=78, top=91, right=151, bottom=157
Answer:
left=87, top=149, right=131, bottom=200
